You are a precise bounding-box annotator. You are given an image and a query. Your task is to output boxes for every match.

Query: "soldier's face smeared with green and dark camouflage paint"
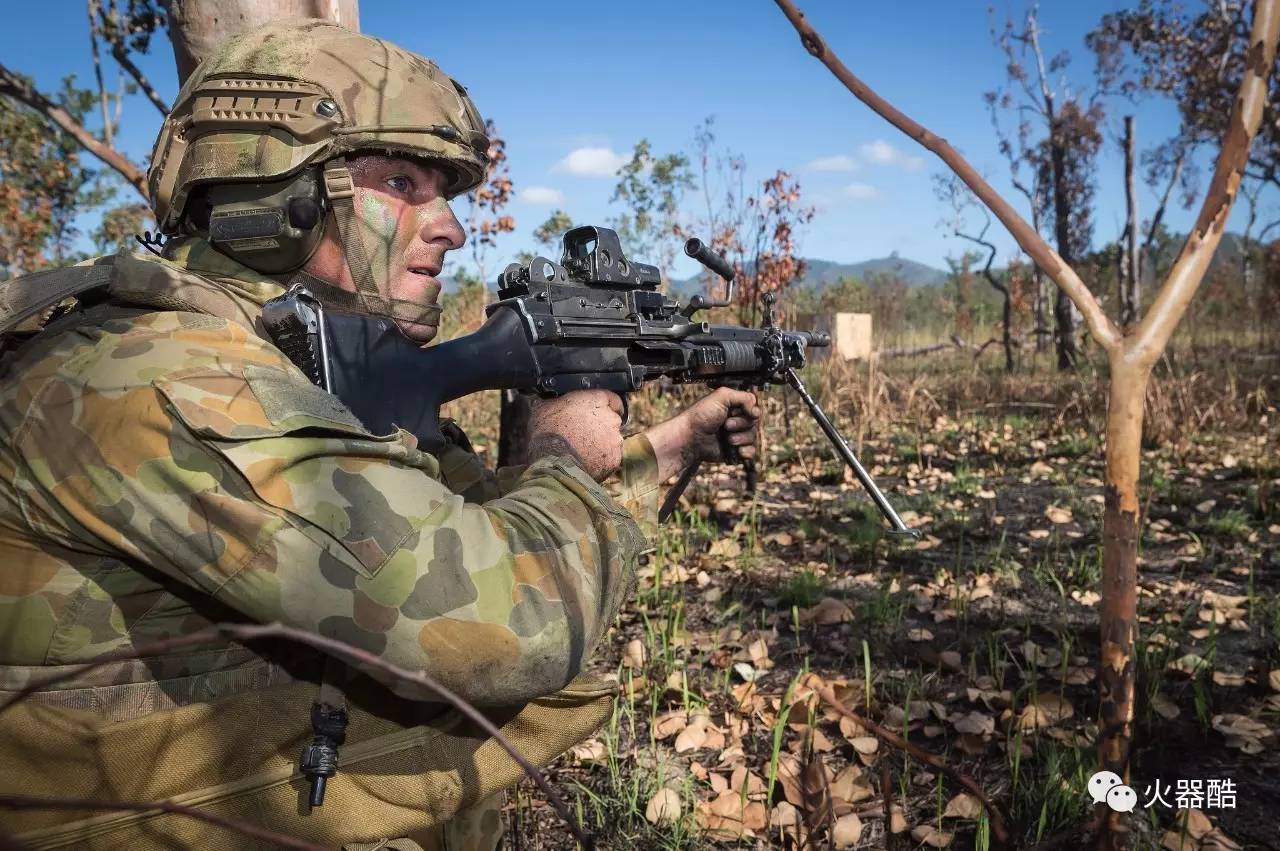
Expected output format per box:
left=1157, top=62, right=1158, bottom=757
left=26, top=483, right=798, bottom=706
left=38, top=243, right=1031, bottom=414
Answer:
left=305, top=155, right=466, bottom=343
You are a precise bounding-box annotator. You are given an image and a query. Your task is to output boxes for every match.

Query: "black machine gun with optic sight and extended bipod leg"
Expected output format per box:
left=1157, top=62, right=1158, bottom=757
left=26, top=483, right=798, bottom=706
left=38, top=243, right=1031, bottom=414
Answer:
left=262, top=227, right=915, bottom=535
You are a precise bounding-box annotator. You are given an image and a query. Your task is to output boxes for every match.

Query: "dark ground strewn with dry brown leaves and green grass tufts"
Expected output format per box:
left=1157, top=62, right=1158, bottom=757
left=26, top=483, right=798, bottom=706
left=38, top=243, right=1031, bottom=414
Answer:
left=496, top=350, right=1280, bottom=850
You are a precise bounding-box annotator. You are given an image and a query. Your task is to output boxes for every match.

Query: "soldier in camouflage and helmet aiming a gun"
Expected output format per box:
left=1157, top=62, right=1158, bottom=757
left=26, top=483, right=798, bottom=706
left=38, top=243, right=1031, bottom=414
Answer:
left=0, top=22, right=759, bottom=848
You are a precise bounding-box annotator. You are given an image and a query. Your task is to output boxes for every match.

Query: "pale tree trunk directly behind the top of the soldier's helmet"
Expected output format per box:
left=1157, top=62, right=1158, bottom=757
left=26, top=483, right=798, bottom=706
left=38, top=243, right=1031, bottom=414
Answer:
left=169, top=0, right=360, bottom=82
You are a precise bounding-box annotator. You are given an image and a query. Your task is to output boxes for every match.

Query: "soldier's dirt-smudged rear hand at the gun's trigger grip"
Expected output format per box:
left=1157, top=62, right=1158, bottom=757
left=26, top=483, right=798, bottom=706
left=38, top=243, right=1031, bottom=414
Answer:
left=529, top=390, right=622, bottom=481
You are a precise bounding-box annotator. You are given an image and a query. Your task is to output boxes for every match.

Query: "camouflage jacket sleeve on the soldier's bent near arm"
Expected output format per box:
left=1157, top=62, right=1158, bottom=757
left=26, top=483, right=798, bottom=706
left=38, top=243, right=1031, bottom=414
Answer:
left=22, top=314, right=657, bottom=705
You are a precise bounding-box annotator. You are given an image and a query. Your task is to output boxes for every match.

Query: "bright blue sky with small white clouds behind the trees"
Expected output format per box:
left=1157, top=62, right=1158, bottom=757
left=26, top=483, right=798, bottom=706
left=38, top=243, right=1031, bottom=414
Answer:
left=0, top=0, right=1259, bottom=276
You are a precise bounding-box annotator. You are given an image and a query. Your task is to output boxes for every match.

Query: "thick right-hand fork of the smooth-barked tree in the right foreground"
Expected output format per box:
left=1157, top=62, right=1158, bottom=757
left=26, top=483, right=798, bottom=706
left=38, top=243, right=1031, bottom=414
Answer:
left=1128, top=0, right=1280, bottom=367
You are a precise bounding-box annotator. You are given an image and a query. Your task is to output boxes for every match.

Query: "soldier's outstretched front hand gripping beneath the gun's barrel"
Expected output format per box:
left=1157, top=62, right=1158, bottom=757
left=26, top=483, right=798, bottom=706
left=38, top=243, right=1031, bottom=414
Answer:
left=645, top=388, right=760, bottom=480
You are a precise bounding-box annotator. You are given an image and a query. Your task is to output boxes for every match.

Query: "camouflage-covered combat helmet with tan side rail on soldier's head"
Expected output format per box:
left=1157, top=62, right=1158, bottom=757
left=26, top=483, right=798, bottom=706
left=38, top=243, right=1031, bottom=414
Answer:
left=147, top=20, right=489, bottom=233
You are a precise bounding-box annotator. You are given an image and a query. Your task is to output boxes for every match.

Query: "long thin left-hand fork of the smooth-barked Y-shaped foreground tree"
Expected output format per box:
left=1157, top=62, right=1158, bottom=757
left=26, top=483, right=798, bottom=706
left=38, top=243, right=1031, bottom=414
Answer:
left=774, top=0, right=1121, bottom=352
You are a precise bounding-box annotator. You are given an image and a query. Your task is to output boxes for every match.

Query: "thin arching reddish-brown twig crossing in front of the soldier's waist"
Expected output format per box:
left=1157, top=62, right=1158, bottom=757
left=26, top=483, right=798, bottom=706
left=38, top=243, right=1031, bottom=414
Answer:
left=0, top=623, right=595, bottom=850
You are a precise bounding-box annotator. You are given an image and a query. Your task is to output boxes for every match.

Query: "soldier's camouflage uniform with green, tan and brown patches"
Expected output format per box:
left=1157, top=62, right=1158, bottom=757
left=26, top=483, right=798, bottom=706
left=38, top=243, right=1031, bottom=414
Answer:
left=0, top=239, right=658, bottom=847
